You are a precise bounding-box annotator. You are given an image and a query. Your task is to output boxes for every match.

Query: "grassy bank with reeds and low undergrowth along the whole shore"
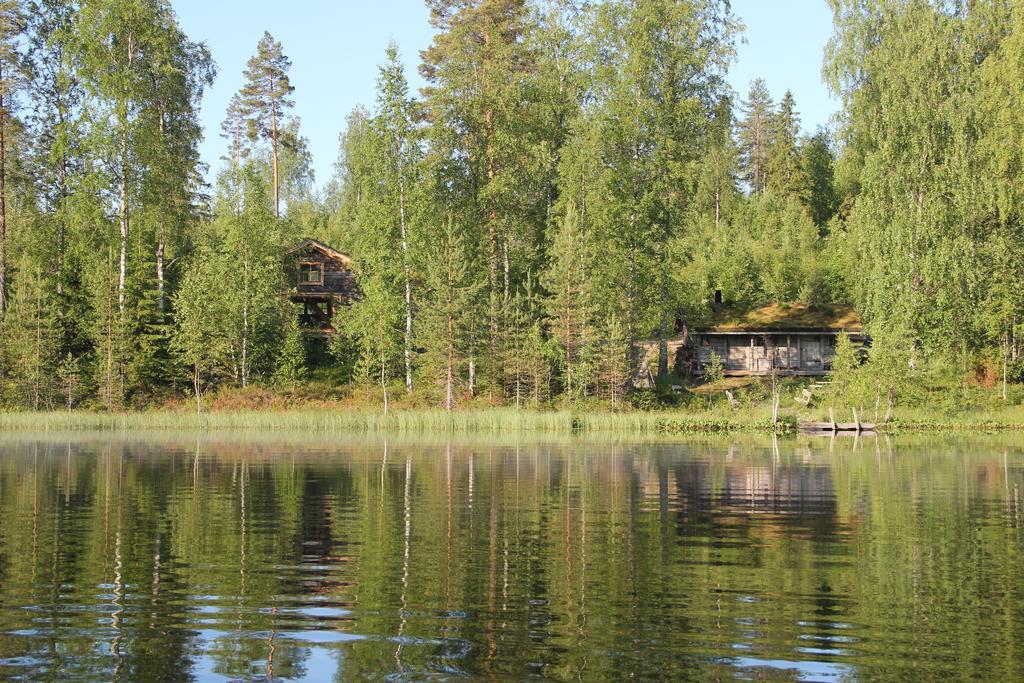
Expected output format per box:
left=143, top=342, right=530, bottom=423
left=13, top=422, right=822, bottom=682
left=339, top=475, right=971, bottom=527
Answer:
left=6, top=381, right=1024, bottom=436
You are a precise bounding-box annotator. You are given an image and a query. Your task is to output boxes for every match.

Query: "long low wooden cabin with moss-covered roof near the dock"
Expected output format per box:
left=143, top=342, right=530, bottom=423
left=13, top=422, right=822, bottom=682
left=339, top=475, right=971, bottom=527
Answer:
left=690, top=303, right=865, bottom=376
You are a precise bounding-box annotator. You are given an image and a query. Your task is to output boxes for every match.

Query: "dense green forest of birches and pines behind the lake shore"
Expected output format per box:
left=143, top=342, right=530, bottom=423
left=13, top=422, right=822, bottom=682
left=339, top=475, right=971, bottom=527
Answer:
left=0, top=0, right=1024, bottom=410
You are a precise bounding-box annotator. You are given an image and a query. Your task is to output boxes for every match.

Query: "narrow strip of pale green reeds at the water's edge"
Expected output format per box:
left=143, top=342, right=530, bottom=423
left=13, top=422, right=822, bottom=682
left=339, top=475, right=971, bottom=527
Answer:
left=6, top=407, right=1024, bottom=435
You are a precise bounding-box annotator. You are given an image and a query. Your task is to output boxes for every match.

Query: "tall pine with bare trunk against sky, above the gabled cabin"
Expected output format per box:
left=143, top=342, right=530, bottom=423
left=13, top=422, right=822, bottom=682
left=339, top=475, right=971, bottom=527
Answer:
left=240, top=32, right=295, bottom=217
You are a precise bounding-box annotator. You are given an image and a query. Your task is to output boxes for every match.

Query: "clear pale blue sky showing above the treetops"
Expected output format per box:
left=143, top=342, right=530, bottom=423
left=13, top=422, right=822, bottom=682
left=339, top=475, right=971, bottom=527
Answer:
left=173, top=0, right=838, bottom=187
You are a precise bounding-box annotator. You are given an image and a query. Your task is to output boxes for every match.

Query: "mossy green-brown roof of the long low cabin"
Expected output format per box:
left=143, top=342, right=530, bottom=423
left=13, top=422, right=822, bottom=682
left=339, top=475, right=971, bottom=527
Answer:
left=693, top=302, right=864, bottom=334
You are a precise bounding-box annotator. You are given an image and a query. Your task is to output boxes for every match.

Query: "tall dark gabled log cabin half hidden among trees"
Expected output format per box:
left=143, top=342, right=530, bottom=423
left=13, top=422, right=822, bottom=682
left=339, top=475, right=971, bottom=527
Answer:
left=288, top=238, right=359, bottom=336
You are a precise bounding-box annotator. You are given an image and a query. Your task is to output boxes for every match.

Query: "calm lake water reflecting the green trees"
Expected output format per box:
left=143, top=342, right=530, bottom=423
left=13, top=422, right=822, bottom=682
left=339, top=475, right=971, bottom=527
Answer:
left=0, top=434, right=1024, bottom=681
